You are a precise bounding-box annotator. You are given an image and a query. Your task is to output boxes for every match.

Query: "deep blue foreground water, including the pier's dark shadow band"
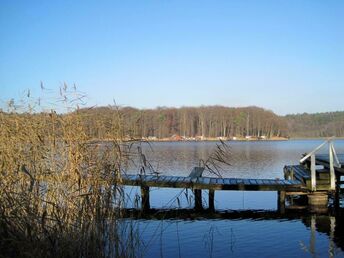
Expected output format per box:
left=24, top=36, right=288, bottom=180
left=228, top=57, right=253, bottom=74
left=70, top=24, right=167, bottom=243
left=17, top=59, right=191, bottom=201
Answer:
left=122, top=208, right=344, bottom=257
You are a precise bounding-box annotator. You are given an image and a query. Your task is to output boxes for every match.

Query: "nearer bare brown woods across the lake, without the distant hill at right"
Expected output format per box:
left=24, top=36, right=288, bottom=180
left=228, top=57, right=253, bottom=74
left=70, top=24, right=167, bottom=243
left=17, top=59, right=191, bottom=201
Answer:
left=78, top=106, right=288, bottom=139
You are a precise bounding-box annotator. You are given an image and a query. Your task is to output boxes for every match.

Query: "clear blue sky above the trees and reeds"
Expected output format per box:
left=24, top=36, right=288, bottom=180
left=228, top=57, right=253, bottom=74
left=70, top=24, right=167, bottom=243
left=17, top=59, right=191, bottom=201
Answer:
left=0, top=0, right=344, bottom=115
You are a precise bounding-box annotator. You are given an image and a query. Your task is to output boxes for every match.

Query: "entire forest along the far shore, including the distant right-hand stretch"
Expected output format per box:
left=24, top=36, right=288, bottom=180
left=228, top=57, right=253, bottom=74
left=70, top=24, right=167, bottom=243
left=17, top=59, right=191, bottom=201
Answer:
left=77, top=106, right=344, bottom=139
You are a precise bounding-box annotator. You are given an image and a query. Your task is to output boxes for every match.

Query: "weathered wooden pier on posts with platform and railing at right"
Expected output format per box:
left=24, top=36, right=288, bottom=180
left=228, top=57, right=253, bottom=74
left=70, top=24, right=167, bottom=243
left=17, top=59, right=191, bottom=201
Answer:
left=120, top=140, right=344, bottom=213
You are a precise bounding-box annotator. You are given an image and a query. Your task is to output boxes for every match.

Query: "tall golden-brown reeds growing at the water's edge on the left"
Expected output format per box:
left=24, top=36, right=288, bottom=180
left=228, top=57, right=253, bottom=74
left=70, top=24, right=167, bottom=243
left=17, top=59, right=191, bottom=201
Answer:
left=0, top=85, right=136, bottom=257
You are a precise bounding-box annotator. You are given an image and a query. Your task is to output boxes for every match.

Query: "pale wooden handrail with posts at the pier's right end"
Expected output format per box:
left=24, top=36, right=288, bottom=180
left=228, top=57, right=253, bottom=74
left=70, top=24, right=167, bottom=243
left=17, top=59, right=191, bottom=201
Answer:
left=300, top=137, right=341, bottom=191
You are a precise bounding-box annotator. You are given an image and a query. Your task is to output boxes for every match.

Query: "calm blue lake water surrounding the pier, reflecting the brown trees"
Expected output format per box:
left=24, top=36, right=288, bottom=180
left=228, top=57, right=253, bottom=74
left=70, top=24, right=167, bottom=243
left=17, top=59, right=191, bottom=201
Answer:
left=121, top=140, right=344, bottom=257
